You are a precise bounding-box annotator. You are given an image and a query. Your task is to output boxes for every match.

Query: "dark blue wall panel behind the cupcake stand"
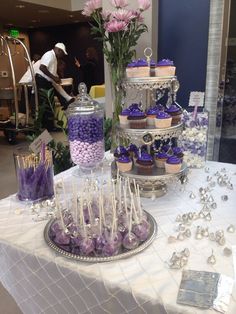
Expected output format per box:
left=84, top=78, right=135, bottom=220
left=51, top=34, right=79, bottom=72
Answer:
left=158, top=0, right=210, bottom=107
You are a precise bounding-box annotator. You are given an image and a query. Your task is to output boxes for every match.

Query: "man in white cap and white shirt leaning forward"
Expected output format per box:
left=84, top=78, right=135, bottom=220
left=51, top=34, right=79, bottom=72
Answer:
left=35, top=43, right=75, bottom=131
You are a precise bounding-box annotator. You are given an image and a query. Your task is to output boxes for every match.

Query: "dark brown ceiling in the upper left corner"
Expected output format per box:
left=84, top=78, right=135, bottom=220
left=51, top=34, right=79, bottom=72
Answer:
left=0, top=0, right=87, bottom=28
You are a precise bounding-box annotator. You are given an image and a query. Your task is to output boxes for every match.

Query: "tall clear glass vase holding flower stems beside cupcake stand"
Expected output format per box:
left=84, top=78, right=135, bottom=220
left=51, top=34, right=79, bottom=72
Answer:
left=110, top=63, right=125, bottom=152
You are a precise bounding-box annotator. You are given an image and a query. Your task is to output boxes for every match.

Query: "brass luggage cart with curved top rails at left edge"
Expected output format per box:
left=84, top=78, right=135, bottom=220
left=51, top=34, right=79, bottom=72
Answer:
left=0, top=34, right=38, bottom=144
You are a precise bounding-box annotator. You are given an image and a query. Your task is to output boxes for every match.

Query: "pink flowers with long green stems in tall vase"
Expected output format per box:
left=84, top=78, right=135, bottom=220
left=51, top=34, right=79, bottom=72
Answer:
left=82, top=0, right=151, bottom=121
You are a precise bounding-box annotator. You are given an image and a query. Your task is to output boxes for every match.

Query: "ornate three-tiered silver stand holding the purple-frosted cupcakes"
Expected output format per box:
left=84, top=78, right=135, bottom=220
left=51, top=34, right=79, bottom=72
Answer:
left=115, top=76, right=188, bottom=198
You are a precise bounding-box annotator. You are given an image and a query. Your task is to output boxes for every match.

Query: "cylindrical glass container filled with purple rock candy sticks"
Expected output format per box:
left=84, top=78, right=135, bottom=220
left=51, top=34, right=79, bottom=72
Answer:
left=14, top=148, right=54, bottom=202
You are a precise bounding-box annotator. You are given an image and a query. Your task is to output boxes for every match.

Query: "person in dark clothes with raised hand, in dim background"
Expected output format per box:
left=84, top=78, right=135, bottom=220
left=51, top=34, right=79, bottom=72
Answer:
left=75, top=47, right=101, bottom=93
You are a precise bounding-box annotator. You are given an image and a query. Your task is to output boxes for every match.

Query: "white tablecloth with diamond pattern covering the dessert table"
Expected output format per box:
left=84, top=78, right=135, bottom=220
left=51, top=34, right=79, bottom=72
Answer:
left=0, top=162, right=236, bottom=314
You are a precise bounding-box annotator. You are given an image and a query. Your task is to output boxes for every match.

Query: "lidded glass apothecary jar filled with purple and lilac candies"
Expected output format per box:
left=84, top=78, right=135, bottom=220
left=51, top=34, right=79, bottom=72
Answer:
left=67, top=83, right=105, bottom=170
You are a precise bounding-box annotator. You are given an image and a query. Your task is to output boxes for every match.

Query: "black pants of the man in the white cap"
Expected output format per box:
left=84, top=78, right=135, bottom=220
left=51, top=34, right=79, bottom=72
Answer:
left=35, top=74, right=67, bottom=131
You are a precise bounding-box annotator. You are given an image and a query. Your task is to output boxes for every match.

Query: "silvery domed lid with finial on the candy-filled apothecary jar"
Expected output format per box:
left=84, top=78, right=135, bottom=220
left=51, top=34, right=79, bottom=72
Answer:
left=66, top=83, right=103, bottom=116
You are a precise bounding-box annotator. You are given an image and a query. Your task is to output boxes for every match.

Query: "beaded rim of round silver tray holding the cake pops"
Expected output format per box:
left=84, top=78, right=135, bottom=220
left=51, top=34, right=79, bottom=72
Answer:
left=44, top=211, right=157, bottom=263
